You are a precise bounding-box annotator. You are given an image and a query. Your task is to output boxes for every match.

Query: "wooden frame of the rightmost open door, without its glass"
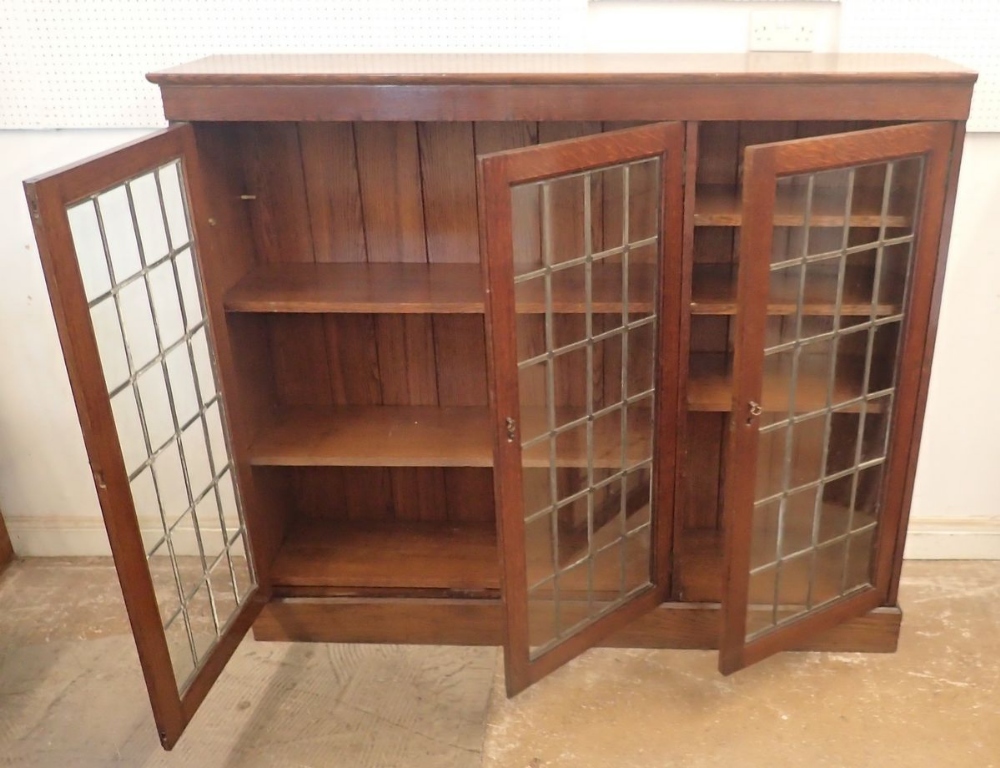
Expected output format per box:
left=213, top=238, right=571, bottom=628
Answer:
left=719, top=122, right=954, bottom=674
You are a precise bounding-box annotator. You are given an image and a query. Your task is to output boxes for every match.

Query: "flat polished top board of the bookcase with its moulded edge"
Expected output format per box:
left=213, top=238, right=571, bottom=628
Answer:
left=147, top=53, right=976, bottom=85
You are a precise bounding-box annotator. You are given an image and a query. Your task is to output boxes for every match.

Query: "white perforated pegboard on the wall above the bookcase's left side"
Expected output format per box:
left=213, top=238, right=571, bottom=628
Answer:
left=0, top=0, right=586, bottom=128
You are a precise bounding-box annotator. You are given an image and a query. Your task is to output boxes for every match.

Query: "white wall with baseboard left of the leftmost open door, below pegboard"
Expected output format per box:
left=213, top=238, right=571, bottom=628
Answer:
left=0, top=130, right=146, bottom=555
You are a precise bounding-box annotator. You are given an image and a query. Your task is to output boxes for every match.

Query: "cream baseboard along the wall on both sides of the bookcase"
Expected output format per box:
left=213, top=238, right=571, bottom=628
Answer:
left=7, top=517, right=1000, bottom=560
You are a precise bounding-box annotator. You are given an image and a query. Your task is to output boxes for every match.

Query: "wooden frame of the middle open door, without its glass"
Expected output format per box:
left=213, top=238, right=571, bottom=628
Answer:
left=478, top=123, right=684, bottom=696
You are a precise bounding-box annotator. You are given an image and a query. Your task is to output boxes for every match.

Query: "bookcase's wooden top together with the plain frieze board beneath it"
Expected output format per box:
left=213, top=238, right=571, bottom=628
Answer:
left=147, top=53, right=976, bottom=122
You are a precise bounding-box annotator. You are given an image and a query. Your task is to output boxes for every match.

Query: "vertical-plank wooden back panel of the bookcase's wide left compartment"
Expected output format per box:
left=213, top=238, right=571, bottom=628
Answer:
left=216, top=122, right=684, bottom=522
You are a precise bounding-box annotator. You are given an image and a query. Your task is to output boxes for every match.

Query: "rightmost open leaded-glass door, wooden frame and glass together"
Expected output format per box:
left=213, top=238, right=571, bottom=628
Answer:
left=719, top=123, right=952, bottom=674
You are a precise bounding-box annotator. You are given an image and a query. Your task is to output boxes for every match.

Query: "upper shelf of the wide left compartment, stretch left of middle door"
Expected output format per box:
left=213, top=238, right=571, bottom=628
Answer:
left=225, top=263, right=485, bottom=314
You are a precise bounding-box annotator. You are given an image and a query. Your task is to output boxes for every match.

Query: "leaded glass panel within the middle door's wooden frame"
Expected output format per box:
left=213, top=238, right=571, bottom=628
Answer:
left=511, top=158, right=662, bottom=658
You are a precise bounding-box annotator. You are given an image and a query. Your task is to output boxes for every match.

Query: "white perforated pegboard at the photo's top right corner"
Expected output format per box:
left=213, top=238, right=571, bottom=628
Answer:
left=841, top=0, right=1000, bottom=131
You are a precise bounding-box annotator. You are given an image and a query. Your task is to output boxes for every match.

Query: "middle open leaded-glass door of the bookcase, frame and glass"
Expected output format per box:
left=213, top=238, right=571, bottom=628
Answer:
left=479, top=124, right=684, bottom=695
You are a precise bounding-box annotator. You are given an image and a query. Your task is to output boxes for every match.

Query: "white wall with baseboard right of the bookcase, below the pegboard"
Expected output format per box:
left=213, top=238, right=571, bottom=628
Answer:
left=907, top=133, right=1000, bottom=558
